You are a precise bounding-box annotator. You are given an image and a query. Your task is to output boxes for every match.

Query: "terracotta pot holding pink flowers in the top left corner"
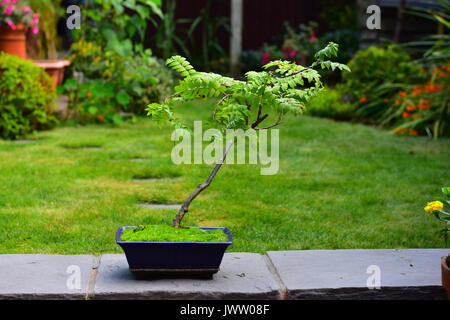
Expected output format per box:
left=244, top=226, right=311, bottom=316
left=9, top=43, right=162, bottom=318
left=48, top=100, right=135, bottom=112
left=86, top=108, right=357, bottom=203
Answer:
left=0, top=25, right=27, bottom=59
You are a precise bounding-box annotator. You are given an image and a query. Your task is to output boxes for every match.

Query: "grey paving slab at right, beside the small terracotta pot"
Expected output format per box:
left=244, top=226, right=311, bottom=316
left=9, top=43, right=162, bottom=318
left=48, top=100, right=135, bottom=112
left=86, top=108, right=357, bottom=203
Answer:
left=267, top=249, right=450, bottom=299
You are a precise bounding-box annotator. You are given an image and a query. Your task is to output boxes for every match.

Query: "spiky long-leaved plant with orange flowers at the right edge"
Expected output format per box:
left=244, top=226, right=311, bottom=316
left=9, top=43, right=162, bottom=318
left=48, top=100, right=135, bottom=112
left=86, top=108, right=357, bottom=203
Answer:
left=383, top=0, right=450, bottom=139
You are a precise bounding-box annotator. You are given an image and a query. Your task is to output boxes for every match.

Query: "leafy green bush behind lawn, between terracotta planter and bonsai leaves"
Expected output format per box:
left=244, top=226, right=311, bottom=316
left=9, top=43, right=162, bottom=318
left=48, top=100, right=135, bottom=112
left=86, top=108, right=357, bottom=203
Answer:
left=60, top=41, right=173, bottom=124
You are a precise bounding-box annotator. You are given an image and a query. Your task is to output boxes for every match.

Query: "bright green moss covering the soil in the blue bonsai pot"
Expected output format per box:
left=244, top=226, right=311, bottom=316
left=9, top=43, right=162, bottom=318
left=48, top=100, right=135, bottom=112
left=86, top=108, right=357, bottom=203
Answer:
left=121, top=225, right=228, bottom=242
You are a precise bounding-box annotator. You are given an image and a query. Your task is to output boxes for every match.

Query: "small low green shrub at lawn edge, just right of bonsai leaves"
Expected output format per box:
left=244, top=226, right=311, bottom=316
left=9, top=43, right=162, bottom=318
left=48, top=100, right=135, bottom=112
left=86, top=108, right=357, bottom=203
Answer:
left=306, top=89, right=355, bottom=120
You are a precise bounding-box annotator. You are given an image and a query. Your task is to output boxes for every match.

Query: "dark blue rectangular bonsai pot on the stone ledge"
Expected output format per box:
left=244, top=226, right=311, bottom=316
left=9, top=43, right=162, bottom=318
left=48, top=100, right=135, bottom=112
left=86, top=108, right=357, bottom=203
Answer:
left=116, top=227, right=233, bottom=277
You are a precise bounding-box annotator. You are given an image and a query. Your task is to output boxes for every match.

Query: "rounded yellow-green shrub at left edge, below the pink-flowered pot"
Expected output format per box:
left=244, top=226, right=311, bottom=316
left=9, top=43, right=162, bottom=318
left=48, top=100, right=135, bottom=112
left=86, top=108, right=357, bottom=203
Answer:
left=0, top=53, right=57, bottom=139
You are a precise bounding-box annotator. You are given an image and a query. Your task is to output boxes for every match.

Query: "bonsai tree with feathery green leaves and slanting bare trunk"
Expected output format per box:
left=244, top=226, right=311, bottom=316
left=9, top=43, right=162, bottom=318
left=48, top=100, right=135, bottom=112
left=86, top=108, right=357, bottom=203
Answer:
left=147, top=42, right=350, bottom=228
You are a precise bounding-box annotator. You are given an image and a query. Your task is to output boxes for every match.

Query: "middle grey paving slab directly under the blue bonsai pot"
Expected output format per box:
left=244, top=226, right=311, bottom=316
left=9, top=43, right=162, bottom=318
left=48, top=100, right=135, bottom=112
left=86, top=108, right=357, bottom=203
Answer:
left=93, top=253, right=281, bottom=299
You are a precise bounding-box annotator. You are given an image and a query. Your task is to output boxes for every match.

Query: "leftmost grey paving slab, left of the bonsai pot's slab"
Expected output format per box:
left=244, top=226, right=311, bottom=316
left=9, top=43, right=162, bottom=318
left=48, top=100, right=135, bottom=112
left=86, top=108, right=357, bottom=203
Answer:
left=0, top=254, right=94, bottom=299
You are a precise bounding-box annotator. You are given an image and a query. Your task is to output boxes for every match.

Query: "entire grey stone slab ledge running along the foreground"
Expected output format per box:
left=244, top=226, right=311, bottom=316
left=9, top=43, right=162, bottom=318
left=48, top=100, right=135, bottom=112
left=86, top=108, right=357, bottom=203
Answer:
left=0, top=249, right=450, bottom=300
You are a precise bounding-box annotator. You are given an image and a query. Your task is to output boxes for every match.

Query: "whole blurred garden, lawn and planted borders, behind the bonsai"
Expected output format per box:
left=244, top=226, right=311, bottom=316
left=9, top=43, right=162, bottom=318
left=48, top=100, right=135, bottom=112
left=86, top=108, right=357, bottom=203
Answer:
left=0, top=0, right=450, bottom=254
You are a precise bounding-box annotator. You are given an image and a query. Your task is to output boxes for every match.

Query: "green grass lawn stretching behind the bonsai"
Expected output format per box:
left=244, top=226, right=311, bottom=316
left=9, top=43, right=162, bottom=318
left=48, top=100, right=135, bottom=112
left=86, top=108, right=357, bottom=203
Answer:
left=0, top=104, right=450, bottom=254
